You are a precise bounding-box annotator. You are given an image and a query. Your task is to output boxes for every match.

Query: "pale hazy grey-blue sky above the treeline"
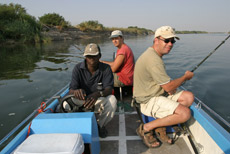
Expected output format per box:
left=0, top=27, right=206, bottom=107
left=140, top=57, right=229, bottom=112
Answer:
left=0, top=0, right=230, bottom=32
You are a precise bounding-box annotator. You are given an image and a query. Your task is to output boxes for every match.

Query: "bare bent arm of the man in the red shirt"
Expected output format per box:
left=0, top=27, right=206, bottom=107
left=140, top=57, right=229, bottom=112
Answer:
left=101, top=55, right=125, bottom=73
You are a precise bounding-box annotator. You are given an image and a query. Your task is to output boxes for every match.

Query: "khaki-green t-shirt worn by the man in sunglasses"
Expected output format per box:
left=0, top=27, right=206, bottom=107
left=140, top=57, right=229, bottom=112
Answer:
left=133, top=47, right=170, bottom=103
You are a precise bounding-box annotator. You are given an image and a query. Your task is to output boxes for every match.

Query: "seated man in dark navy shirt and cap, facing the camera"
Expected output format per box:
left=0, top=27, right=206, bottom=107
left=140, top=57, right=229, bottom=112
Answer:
left=69, top=43, right=117, bottom=138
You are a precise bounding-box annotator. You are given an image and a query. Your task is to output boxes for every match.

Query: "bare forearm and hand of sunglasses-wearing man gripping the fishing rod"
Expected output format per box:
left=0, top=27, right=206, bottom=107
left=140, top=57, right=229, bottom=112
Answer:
left=161, top=71, right=194, bottom=94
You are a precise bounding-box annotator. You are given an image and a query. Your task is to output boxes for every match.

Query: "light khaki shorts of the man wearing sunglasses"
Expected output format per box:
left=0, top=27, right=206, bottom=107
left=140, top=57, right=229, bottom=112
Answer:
left=140, top=90, right=183, bottom=118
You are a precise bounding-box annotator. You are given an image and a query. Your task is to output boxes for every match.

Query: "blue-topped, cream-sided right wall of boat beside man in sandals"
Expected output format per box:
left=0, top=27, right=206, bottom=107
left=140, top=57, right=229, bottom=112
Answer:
left=186, top=103, right=230, bottom=154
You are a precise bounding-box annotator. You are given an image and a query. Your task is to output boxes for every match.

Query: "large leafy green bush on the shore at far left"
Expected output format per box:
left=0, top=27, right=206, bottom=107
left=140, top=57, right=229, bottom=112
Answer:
left=0, top=3, right=41, bottom=42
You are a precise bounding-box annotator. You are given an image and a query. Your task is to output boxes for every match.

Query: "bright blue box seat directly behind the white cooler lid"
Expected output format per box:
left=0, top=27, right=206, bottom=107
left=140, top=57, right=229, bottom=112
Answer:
left=30, top=112, right=100, bottom=154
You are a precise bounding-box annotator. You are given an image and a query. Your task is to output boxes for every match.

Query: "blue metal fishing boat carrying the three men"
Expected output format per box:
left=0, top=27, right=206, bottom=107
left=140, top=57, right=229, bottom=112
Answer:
left=0, top=85, right=230, bottom=154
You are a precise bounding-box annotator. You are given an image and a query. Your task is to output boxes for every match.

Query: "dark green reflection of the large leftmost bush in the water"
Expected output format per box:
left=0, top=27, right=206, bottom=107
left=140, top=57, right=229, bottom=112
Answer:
left=0, top=46, right=41, bottom=80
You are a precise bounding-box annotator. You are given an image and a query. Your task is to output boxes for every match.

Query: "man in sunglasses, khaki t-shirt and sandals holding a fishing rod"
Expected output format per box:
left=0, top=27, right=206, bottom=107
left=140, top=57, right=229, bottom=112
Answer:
left=133, top=26, right=194, bottom=148
